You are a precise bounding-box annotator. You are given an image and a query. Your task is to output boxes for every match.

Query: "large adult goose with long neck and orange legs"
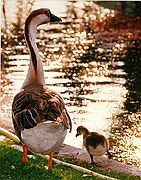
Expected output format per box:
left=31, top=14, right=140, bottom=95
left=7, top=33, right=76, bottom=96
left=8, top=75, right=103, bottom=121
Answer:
left=12, top=8, right=72, bottom=168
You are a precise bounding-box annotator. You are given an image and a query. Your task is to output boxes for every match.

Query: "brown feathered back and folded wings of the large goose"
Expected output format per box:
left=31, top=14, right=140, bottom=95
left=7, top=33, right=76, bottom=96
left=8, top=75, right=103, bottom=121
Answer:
left=12, top=89, right=71, bottom=138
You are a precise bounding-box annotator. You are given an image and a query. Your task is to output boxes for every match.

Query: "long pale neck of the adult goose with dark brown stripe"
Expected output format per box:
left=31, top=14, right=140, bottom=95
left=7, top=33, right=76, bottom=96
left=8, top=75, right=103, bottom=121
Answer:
left=22, top=17, right=45, bottom=88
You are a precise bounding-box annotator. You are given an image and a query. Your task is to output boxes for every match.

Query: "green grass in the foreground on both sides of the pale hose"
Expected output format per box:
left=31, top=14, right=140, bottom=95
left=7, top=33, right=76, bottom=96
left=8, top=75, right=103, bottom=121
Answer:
left=0, top=136, right=139, bottom=180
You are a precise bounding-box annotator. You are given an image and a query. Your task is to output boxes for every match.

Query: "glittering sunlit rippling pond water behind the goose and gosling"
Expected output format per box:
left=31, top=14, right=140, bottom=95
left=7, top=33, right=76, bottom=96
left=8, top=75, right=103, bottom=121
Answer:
left=0, top=0, right=141, bottom=167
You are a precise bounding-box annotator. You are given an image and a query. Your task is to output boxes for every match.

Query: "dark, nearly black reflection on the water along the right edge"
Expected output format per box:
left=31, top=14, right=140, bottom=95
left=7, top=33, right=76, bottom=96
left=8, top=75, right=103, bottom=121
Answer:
left=123, top=40, right=141, bottom=112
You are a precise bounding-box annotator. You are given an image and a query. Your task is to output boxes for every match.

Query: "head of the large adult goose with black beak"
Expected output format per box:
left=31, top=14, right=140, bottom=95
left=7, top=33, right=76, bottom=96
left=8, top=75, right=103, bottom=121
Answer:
left=26, top=8, right=62, bottom=26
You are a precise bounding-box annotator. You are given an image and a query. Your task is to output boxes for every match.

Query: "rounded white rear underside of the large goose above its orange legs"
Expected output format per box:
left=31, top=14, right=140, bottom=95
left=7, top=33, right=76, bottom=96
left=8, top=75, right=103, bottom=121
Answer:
left=21, top=122, right=67, bottom=154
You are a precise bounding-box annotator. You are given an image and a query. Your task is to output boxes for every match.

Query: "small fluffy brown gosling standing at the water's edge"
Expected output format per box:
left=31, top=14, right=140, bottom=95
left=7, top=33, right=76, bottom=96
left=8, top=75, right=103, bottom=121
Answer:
left=76, top=126, right=112, bottom=163
